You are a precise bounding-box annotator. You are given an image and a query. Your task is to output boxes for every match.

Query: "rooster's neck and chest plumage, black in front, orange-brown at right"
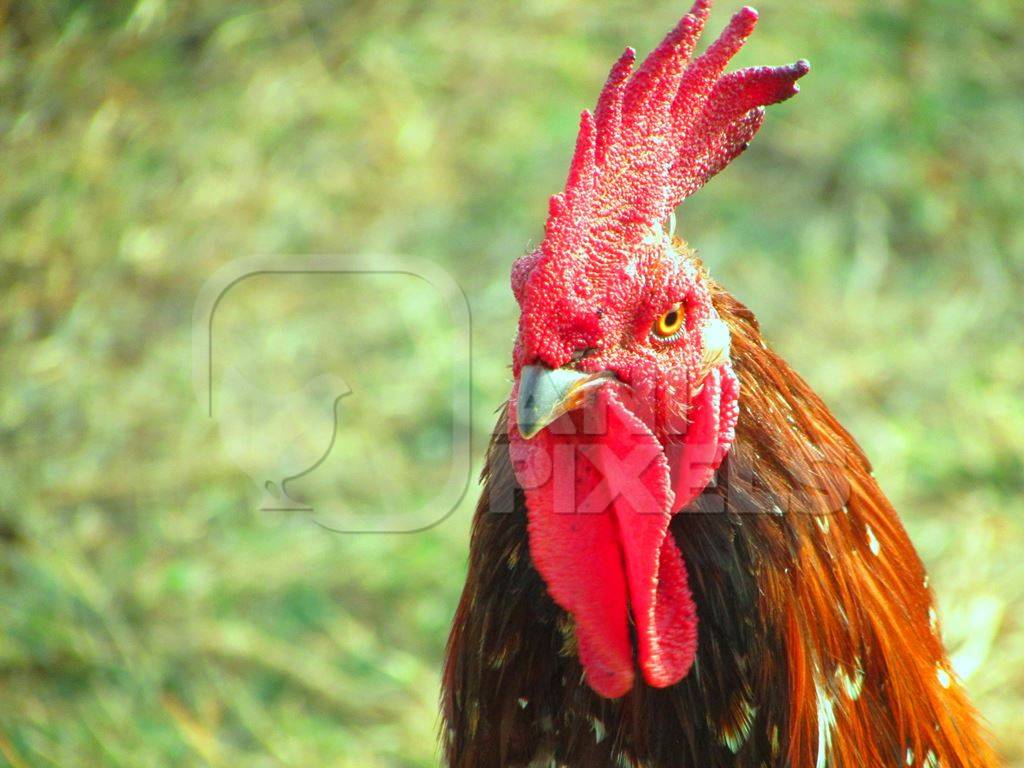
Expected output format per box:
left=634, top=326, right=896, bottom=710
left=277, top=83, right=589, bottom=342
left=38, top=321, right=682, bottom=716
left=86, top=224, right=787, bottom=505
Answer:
left=442, top=291, right=997, bottom=768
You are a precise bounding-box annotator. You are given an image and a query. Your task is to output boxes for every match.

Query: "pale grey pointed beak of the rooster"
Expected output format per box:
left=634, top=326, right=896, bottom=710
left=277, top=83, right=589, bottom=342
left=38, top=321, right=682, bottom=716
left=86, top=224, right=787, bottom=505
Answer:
left=515, top=366, right=614, bottom=440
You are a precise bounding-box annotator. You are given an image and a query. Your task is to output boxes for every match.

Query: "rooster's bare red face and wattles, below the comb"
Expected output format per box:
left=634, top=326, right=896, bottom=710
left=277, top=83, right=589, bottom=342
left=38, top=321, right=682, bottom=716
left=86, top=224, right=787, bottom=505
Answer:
left=510, top=239, right=738, bottom=697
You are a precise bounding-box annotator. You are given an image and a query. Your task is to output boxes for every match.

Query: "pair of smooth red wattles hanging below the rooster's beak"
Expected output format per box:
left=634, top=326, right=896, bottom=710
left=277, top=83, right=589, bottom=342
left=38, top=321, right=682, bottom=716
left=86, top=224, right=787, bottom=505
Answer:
left=509, top=387, right=696, bottom=697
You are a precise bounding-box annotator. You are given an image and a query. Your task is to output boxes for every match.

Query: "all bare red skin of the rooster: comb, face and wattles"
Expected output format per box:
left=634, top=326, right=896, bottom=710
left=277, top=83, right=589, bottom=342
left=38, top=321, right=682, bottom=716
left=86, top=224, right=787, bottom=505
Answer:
left=509, top=0, right=808, bottom=697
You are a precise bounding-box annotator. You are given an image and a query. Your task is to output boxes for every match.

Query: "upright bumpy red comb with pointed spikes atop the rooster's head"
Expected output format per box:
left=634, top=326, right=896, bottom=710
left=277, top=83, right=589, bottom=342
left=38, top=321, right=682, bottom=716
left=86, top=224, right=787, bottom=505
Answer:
left=541, top=0, right=810, bottom=270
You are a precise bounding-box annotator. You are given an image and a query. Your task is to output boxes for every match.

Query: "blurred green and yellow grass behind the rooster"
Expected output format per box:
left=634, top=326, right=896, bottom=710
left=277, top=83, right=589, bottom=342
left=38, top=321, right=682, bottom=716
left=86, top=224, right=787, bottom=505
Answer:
left=0, top=0, right=1024, bottom=768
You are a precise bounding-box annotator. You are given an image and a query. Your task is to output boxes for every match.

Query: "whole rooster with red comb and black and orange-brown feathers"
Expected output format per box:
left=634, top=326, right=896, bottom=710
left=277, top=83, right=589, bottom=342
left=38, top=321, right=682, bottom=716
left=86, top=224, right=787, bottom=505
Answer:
left=442, top=0, right=997, bottom=768
